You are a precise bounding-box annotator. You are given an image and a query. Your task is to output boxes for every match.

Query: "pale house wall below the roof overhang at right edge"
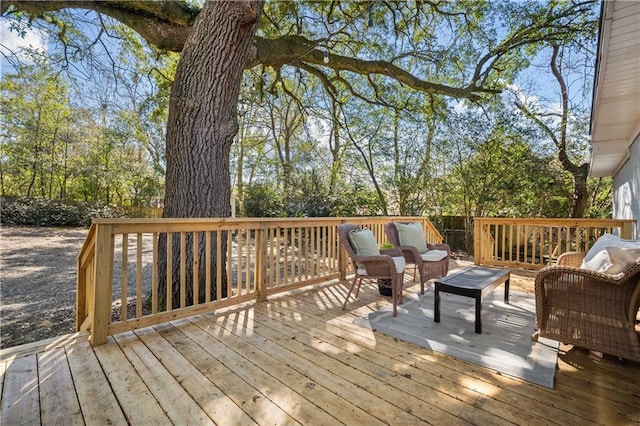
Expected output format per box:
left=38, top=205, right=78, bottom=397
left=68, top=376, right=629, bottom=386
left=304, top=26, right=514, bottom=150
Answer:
left=613, top=135, right=640, bottom=240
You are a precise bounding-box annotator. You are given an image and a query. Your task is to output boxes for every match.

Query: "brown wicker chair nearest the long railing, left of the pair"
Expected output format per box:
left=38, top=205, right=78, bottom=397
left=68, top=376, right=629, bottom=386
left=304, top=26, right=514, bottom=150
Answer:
left=338, top=223, right=404, bottom=317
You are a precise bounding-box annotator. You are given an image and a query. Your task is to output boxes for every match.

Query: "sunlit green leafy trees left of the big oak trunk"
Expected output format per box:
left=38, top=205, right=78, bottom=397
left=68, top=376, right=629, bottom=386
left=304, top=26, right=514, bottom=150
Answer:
left=0, top=63, right=161, bottom=205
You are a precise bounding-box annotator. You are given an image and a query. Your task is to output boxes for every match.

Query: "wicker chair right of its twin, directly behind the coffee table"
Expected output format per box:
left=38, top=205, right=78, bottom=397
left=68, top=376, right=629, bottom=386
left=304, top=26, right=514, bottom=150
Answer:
left=384, top=222, right=451, bottom=294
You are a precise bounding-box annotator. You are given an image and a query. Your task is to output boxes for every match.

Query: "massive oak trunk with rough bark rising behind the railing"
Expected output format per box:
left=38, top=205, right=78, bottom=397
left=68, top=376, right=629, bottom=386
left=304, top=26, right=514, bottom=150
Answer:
left=159, top=0, right=262, bottom=306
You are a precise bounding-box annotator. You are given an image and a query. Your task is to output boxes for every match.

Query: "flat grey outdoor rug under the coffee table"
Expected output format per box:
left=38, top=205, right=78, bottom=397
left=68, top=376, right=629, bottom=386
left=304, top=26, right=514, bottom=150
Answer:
left=354, top=287, right=558, bottom=388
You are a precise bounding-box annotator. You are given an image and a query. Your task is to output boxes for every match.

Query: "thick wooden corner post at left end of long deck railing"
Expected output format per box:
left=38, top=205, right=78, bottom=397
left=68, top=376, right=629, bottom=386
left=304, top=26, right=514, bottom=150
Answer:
left=90, top=224, right=114, bottom=346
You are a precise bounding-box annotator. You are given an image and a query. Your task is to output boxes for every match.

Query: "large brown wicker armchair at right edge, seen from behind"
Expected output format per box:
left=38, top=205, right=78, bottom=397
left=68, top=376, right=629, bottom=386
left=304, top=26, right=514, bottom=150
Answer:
left=535, top=252, right=640, bottom=361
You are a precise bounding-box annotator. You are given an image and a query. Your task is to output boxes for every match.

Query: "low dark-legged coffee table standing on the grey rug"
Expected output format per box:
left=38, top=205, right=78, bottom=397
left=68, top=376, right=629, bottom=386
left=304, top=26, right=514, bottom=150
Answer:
left=433, top=266, right=511, bottom=333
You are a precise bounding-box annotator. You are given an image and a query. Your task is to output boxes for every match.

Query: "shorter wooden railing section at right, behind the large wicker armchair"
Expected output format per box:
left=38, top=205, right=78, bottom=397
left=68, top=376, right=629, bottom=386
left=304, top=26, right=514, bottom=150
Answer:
left=473, top=217, right=634, bottom=269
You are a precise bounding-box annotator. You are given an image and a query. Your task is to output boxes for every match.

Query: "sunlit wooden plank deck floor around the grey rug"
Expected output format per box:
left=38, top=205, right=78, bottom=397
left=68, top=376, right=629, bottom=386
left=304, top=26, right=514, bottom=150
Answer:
left=0, top=264, right=640, bottom=425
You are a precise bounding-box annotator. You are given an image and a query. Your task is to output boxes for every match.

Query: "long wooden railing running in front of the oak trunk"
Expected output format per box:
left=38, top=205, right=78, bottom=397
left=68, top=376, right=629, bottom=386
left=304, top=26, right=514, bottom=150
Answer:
left=76, top=217, right=442, bottom=345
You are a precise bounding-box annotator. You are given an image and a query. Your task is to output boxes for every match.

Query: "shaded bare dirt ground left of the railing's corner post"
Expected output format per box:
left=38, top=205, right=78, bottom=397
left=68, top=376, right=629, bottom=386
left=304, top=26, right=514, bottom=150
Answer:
left=0, top=226, right=87, bottom=348
